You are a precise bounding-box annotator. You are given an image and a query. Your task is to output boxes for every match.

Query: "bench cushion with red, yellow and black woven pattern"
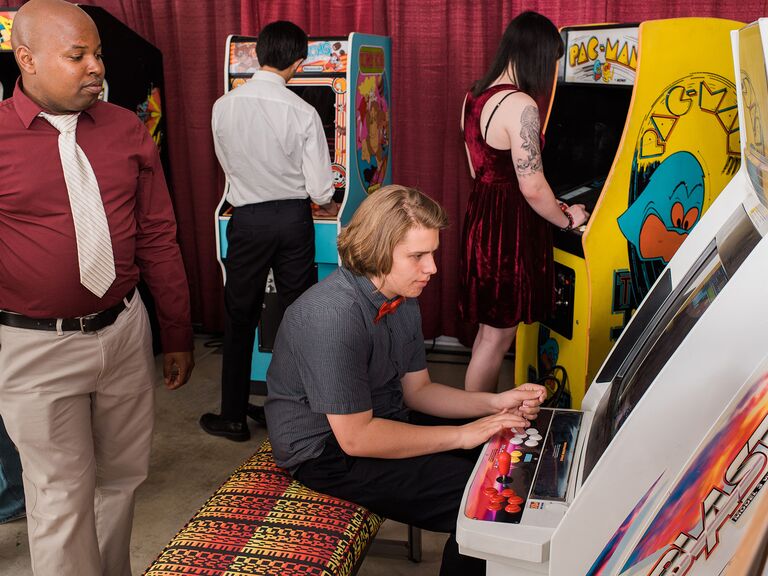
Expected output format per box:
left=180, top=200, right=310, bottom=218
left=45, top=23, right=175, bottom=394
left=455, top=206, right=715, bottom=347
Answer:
left=144, top=440, right=384, bottom=576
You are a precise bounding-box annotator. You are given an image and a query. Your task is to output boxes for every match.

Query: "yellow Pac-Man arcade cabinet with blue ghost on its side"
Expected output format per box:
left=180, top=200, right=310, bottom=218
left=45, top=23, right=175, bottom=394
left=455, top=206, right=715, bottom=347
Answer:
left=515, top=18, right=741, bottom=408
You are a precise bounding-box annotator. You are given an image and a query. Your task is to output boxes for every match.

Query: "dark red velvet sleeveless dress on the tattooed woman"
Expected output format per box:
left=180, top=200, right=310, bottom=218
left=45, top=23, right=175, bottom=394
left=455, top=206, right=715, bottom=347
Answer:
left=459, top=84, right=554, bottom=328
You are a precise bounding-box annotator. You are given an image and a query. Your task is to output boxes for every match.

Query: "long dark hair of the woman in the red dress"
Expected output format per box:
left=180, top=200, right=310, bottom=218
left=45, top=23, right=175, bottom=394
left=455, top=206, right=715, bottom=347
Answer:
left=472, top=11, right=564, bottom=100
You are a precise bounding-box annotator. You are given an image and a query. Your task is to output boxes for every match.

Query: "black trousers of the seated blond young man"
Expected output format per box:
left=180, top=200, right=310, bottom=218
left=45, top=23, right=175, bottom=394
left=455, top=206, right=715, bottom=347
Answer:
left=294, top=413, right=485, bottom=576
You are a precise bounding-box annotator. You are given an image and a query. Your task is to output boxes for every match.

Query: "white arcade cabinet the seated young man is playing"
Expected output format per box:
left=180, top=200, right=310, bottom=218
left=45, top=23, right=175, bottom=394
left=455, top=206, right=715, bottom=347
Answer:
left=457, top=19, right=768, bottom=576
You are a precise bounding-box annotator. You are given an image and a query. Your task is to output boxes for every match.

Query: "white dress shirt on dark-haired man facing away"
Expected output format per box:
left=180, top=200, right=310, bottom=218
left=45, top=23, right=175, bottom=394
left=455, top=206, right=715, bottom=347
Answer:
left=211, top=70, right=333, bottom=206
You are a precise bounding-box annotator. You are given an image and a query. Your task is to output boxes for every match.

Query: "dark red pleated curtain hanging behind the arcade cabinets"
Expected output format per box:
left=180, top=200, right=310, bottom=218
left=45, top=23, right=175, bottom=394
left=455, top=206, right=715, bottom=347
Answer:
left=7, top=0, right=768, bottom=338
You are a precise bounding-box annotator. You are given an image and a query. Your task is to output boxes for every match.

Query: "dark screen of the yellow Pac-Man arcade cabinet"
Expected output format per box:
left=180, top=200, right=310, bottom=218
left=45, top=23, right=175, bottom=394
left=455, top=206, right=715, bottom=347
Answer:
left=541, top=83, right=632, bottom=209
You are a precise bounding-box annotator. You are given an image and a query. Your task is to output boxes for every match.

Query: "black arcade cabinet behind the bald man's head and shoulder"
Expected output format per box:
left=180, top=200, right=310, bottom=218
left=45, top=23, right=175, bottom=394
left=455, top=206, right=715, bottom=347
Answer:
left=0, top=5, right=170, bottom=354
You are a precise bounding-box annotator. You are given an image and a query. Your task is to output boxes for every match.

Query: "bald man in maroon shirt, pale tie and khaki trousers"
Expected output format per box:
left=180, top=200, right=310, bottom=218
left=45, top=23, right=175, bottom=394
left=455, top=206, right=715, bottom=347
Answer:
left=0, top=0, right=193, bottom=576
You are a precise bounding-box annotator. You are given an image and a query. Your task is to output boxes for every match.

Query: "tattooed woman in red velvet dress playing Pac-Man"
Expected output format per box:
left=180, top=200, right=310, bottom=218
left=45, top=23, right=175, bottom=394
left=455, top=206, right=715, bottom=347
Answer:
left=459, top=12, right=587, bottom=391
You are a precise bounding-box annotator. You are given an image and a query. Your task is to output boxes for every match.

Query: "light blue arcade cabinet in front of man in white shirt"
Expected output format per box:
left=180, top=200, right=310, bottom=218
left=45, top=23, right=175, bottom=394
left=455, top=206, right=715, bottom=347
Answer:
left=215, top=32, right=392, bottom=393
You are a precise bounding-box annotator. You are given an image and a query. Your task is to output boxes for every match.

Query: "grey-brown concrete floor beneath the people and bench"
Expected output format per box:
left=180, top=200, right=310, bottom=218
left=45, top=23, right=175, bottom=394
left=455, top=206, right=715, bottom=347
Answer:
left=0, top=337, right=511, bottom=576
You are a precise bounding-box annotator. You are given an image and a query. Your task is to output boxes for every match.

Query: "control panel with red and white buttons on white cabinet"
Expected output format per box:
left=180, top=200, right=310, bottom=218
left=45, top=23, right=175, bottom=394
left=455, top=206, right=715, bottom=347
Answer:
left=463, top=409, right=584, bottom=527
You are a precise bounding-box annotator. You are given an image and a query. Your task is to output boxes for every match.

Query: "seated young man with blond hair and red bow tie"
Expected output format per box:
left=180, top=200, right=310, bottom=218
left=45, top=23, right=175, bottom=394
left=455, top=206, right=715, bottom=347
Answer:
left=265, top=186, right=546, bottom=576
